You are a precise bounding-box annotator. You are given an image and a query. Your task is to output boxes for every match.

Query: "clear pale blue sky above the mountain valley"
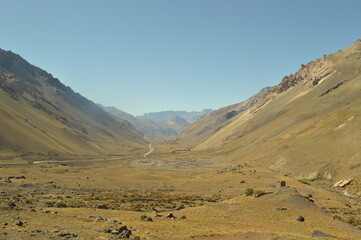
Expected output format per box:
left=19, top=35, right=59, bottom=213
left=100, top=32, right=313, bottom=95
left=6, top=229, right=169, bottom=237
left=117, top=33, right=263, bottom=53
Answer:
left=0, top=0, right=361, bottom=115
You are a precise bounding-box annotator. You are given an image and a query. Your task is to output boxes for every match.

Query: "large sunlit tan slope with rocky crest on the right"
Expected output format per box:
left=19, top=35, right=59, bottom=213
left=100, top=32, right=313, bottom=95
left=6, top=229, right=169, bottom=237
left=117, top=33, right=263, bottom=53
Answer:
left=193, top=40, right=361, bottom=178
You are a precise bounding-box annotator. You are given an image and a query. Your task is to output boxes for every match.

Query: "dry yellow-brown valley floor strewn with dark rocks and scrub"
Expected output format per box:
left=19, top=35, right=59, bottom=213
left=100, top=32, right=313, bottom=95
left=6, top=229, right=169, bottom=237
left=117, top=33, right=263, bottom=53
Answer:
left=0, top=155, right=361, bottom=240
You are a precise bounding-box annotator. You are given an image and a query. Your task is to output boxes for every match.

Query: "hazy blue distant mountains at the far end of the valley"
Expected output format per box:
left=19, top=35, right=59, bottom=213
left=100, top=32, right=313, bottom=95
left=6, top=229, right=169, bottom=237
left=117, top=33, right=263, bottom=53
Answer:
left=99, top=105, right=211, bottom=138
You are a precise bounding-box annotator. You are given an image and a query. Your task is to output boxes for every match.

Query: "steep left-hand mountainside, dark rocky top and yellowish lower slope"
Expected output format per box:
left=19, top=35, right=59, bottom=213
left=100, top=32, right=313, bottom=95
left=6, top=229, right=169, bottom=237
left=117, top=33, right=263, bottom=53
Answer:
left=0, top=50, right=146, bottom=156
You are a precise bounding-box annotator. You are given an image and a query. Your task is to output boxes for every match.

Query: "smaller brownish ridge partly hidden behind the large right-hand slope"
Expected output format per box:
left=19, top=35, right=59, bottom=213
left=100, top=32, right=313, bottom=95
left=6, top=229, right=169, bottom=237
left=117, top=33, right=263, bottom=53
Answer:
left=178, top=87, right=272, bottom=142
